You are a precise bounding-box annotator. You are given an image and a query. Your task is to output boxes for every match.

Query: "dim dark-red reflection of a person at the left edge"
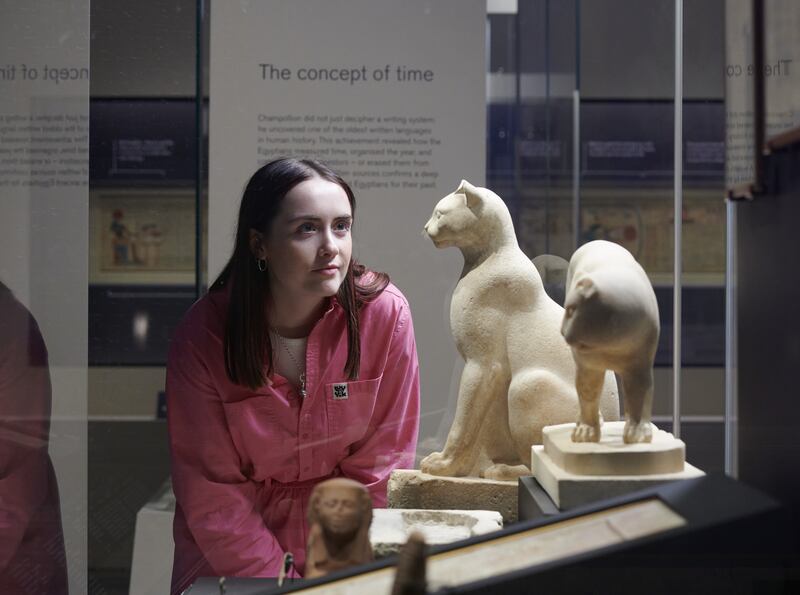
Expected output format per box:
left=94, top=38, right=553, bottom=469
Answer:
left=0, top=282, right=67, bottom=595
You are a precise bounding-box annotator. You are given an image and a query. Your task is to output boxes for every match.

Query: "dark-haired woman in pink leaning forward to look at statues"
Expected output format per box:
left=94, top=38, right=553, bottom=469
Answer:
left=167, top=159, right=419, bottom=593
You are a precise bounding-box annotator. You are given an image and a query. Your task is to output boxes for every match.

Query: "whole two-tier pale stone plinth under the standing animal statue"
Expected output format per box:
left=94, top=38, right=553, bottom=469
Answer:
left=531, top=422, right=704, bottom=510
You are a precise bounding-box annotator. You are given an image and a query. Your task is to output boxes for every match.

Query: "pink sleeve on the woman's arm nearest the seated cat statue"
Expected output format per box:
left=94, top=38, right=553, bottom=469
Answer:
left=339, top=304, right=419, bottom=508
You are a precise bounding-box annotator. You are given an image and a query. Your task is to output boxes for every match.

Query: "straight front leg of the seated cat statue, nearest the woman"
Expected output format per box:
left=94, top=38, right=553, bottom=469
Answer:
left=420, top=360, right=508, bottom=477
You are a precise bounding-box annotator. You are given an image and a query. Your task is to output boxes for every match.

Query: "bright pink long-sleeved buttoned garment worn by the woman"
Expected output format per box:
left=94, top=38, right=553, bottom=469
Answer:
left=167, top=284, right=419, bottom=593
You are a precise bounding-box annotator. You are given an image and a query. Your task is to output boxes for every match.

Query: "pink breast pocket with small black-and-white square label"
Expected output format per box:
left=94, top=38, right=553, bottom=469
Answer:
left=325, top=377, right=381, bottom=446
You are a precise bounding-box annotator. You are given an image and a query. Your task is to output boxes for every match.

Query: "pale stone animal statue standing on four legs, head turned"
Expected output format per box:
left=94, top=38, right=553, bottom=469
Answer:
left=561, top=240, right=659, bottom=443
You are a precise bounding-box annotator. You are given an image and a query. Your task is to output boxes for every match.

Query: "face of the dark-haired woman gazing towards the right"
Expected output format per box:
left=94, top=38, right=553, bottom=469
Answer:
left=263, top=178, right=353, bottom=301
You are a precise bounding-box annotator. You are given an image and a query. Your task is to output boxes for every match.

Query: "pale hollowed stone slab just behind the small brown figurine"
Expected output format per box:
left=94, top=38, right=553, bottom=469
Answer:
left=369, top=508, right=503, bottom=558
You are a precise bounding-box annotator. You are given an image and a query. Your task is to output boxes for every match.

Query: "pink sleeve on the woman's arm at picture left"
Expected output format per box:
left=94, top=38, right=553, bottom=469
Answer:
left=167, top=336, right=296, bottom=576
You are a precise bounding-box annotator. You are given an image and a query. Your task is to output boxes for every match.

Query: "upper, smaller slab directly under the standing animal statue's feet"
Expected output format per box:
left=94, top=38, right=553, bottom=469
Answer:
left=542, top=421, right=686, bottom=476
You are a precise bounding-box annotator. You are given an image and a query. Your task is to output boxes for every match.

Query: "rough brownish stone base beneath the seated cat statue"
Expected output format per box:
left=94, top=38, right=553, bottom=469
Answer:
left=387, top=469, right=517, bottom=524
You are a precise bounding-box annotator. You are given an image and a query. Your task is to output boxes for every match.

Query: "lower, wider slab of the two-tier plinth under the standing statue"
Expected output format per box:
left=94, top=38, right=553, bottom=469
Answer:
left=531, top=445, right=705, bottom=510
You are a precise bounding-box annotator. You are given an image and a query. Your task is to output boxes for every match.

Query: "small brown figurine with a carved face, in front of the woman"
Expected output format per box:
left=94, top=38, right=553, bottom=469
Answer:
left=305, top=477, right=373, bottom=578
